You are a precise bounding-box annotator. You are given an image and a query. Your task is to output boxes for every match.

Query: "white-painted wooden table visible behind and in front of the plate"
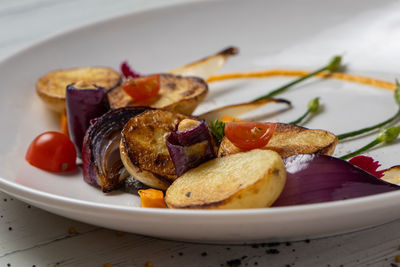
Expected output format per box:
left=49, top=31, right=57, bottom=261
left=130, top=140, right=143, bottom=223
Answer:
left=0, top=0, right=400, bottom=267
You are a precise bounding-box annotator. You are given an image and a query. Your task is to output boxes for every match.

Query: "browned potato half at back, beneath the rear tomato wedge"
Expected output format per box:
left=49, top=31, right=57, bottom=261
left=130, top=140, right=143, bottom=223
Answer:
left=108, top=74, right=208, bottom=114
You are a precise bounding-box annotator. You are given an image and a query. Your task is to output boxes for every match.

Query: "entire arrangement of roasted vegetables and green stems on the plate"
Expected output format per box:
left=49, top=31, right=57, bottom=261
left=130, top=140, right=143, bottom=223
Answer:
left=26, top=47, right=400, bottom=209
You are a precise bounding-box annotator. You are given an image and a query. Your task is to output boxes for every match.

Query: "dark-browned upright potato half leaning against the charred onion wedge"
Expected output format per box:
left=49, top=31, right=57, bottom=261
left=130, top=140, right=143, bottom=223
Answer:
left=120, top=110, right=190, bottom=184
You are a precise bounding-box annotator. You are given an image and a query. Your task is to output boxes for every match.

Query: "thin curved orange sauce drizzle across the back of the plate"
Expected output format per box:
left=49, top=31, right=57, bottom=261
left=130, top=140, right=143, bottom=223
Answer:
left=207, top=69, right=396, bottom=91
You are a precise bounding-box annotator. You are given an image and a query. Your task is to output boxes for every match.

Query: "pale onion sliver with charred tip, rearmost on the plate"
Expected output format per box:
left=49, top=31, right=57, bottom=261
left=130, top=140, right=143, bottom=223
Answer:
left=169, top=47, right=239, bottom=79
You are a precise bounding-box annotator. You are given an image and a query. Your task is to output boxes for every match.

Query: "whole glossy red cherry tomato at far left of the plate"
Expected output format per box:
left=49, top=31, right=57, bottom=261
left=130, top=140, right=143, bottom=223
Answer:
left=25, top=132, right=76, bottom=172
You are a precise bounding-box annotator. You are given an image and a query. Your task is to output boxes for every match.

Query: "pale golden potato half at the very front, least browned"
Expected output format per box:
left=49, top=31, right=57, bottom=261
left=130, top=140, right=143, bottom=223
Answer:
left=165, top=149, right=286, bottom=209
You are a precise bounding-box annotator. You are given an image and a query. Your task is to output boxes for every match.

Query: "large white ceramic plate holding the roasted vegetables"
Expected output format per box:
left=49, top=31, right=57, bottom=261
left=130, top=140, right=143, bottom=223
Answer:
left=0, top=0, right=400, bottom=243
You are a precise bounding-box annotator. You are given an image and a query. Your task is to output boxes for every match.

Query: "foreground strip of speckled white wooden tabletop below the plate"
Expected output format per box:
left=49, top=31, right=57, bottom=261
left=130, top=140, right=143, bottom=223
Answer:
left=0, top=193, right=400, bottom=266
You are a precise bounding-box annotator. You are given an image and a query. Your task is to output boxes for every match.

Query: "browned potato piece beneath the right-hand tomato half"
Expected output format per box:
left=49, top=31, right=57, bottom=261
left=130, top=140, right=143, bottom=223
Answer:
left=218, top=123, right=338, bottom=158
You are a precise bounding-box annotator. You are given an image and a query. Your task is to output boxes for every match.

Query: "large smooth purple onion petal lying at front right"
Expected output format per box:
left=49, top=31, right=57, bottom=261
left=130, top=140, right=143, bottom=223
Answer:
left=273, top=154, right=400, bottom=207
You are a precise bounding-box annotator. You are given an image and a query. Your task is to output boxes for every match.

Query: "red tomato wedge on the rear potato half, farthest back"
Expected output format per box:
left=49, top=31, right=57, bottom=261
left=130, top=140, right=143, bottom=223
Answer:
left=122, top=74, right=161, bottom=102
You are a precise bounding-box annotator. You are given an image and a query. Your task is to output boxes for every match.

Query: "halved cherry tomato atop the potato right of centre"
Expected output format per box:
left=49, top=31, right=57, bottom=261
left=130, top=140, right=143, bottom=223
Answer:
left=225, top=122, right=276, bottom=150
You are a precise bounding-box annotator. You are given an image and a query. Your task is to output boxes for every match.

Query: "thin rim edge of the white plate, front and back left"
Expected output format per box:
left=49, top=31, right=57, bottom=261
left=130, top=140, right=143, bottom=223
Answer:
left=0, top=0, right=400, bottom=226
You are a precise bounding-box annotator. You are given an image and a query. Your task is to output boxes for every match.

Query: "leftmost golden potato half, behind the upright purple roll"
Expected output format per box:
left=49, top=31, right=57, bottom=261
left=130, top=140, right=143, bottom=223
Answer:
left=36, top=67, right=121, bottom=113
